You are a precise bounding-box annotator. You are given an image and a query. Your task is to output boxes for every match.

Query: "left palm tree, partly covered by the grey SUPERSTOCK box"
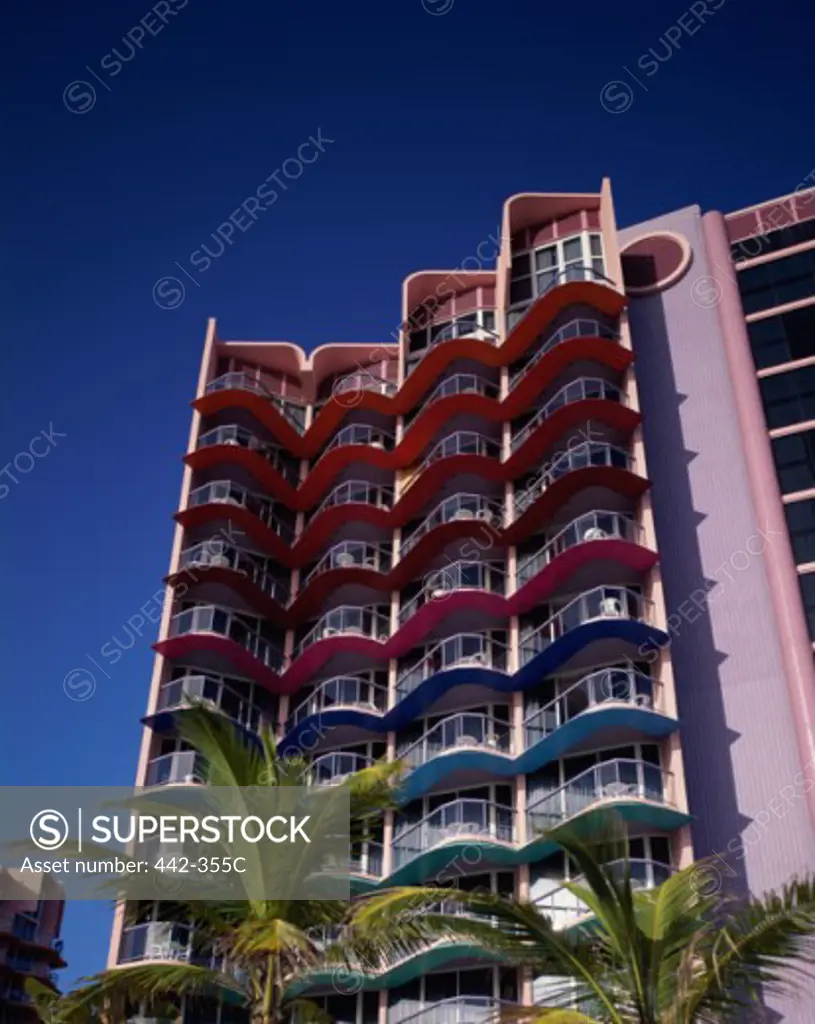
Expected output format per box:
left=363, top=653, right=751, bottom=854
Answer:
left=59, top=706, right=401, bottom=1024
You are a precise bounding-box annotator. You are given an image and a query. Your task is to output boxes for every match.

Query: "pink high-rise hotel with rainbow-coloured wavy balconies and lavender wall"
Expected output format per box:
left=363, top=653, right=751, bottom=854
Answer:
left=111, top=182, right=815, bottom=1024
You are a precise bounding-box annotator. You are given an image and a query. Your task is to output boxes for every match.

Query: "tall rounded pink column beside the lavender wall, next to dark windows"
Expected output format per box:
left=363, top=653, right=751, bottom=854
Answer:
left=702, top=213, right=815, bottom=822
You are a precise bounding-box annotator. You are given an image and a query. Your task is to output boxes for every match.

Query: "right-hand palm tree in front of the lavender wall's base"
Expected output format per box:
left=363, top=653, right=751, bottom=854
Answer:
left=337, top=819, right=815, bottom=1024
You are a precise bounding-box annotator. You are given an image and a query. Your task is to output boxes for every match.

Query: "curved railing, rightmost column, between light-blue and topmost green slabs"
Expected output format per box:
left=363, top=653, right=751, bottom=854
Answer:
left=526, top=758, right=671, bottom=831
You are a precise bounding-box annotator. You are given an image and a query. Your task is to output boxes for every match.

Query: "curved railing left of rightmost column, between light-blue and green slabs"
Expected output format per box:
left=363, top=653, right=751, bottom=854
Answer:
left=393, top=798, right=515, bottom=868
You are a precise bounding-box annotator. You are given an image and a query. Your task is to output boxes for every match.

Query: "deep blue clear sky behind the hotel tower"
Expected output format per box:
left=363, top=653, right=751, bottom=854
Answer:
left=0, top=0, right=815, bottom=980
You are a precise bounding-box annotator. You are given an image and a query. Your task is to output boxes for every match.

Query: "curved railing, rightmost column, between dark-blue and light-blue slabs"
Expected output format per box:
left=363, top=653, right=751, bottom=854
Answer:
left=523, top=669, right=658, bottom=748
